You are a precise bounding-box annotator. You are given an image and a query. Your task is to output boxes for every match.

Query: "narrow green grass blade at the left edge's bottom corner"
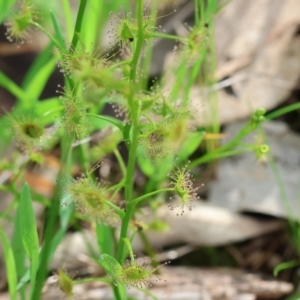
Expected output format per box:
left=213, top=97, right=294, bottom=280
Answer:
left=0, top=229, right=17, bottom=300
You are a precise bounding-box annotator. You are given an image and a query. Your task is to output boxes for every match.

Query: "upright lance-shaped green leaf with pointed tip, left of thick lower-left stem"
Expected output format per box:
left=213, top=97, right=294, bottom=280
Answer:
left=18, top=183, right=39, bottom=291
